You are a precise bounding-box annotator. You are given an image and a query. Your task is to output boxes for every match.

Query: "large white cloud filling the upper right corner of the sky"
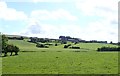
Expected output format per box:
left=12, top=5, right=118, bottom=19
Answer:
left=76, top=0, right=118, bottom=22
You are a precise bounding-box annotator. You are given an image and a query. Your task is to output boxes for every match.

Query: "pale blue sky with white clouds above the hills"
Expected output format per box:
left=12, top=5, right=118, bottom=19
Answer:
left=0, top=0, right=119, bottom=42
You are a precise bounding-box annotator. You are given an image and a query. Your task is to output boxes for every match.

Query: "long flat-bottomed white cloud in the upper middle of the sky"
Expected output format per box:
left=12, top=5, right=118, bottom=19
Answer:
left=31, top=9, right=77, bottom=21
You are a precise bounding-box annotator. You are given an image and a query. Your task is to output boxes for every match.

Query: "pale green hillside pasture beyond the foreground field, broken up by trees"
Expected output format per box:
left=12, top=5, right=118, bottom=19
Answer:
left=9, top=40, right=117, bottom=51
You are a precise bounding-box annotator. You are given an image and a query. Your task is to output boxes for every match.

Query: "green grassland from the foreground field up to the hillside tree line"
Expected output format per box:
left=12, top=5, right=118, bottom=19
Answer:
left=2, top=40, right=118, bottom=74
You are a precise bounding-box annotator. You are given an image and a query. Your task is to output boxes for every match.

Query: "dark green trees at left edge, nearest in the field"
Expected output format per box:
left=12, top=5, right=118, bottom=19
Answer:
left=2, top=35, right=20, bottom=56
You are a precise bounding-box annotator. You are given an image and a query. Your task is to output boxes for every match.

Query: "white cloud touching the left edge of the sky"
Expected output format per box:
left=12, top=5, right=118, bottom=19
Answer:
left=0, top=2, right=27, bottom=20
